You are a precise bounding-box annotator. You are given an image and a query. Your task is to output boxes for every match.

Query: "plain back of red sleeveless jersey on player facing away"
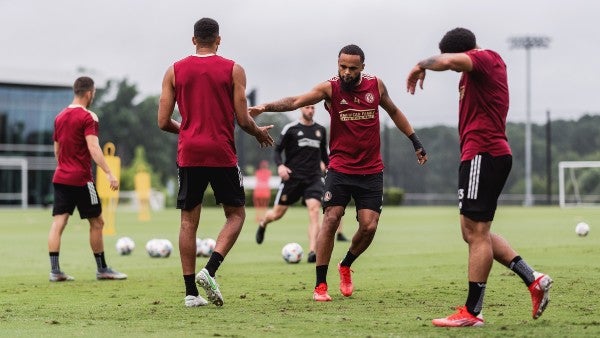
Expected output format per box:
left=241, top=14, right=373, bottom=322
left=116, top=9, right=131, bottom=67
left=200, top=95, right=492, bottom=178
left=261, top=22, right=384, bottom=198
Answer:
left=173, top=55, right=237, bottom=167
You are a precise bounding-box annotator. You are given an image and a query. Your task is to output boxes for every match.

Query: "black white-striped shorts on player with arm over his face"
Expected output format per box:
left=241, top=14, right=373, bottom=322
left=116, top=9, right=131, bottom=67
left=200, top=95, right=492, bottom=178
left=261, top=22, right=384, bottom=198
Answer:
left=458, top=153, right=512, bottom=222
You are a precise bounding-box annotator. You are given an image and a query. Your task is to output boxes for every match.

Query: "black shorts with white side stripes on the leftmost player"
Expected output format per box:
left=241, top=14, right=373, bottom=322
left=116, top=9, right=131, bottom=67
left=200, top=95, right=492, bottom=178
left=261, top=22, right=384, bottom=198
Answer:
left=52, top=182, right=102, bottom=219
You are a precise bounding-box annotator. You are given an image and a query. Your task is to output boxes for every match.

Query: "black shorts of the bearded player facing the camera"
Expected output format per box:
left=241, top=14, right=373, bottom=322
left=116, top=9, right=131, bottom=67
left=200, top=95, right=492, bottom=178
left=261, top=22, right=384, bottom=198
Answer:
left=323, top=170, right=383, bottom=213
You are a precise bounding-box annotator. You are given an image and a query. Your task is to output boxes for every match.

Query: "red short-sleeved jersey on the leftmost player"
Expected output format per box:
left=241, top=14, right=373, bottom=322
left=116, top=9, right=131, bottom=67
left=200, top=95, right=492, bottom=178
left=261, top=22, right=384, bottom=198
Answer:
left=52, top=105, right=98, bottom=186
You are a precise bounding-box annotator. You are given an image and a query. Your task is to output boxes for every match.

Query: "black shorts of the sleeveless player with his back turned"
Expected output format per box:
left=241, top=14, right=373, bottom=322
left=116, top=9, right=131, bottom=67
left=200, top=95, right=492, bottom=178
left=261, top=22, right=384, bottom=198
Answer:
left=177, top=166, right=246, bottom=210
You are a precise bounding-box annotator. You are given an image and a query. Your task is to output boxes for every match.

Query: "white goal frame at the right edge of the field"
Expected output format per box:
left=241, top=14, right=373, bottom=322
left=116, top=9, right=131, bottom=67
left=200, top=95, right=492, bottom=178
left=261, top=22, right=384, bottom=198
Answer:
left=558, top=161, right=600, bottom=208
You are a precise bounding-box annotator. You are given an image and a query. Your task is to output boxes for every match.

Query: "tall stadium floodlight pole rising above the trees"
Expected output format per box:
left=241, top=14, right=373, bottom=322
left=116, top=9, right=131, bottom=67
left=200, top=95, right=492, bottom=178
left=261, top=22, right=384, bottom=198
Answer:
left=508, top=36, right=550, bottom=206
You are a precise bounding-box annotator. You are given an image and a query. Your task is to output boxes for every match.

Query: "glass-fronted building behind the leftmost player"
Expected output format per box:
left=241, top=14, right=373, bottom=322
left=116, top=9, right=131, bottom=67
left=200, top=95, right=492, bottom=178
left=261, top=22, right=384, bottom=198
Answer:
left=0, top=82, right=73, bottom=206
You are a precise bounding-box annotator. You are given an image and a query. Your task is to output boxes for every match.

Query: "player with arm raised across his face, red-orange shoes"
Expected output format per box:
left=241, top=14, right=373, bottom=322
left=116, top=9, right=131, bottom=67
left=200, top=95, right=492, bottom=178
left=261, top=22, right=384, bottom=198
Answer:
left=406, top=28, right=552, bottom=326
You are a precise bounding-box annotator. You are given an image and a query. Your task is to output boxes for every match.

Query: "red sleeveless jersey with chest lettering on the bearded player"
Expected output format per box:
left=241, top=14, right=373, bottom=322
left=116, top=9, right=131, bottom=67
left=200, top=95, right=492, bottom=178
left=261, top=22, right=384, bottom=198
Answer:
left=325, top=74, right=383, bottom=175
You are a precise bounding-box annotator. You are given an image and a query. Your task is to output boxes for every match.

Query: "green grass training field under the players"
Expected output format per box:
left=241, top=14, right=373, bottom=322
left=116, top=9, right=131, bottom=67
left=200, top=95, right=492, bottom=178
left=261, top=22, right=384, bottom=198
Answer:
left=0, top=207, right=600, bottom=337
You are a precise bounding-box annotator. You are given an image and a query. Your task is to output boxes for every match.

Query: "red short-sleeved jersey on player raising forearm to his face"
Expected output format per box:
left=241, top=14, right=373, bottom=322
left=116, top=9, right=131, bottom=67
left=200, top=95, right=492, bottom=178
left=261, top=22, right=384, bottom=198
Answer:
left=458, top=49, right=511, bottom=161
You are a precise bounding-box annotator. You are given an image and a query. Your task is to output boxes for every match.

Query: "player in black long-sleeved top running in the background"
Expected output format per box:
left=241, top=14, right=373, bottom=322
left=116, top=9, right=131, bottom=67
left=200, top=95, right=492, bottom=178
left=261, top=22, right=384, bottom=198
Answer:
left=256, top=105, right=329, bottom=263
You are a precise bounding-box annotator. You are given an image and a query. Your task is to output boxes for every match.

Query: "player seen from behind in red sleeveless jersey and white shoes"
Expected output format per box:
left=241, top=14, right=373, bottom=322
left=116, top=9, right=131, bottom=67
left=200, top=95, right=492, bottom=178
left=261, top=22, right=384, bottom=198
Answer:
left=158, top=18, right=273, bottom=307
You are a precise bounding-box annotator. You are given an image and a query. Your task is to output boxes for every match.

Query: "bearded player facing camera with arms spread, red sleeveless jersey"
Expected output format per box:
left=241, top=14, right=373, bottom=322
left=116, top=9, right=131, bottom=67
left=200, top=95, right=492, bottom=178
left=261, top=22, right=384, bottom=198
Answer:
left=250, top=45, right=427, bottom=301
